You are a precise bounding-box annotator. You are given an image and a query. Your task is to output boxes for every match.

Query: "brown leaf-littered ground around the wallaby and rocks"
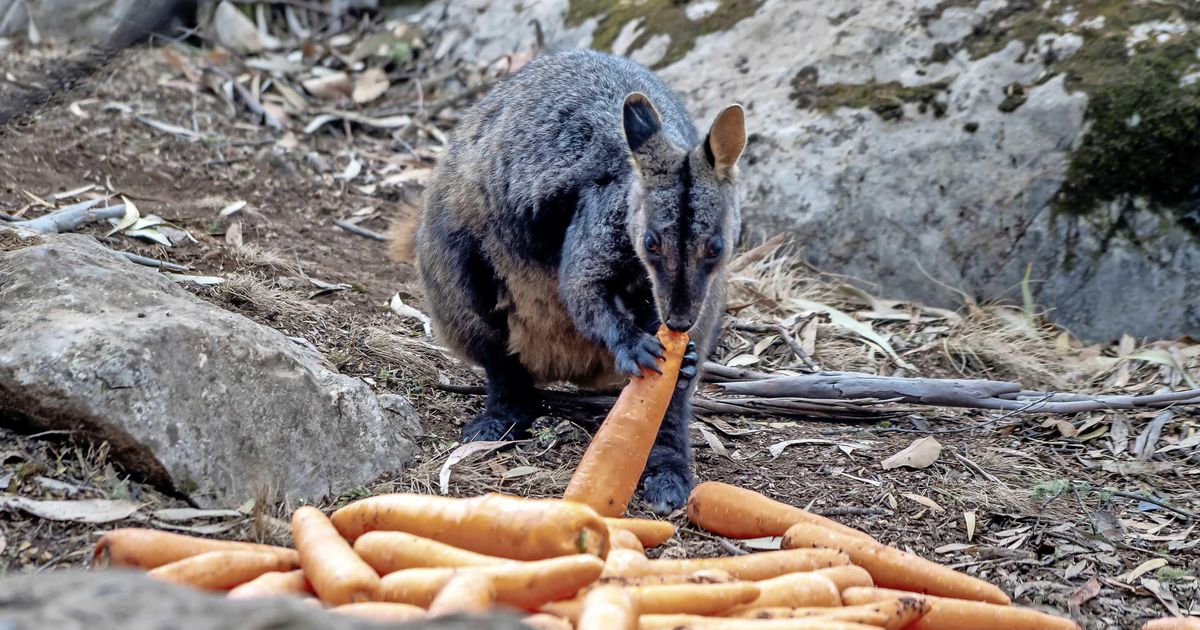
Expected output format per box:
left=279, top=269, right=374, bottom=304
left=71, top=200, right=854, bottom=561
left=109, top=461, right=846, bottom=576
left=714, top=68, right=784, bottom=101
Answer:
left=0, top=15, right=1200, bottom=629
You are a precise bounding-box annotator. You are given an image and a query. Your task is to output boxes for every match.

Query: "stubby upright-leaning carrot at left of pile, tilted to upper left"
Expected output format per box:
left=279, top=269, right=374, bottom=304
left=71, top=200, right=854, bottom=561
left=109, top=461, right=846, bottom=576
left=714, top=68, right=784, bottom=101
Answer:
left=292, top=505, right=379, bottom=606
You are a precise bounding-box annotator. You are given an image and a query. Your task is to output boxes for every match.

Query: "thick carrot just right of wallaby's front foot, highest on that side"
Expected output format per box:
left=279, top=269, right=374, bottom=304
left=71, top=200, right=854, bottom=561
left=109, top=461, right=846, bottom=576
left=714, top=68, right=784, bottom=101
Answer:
left=688, top=481, right=874, bottom=540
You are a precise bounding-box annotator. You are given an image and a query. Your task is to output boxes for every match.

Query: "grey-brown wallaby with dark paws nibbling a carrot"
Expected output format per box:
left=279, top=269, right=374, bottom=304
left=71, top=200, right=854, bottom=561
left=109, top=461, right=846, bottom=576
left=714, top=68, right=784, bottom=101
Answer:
left=392, top=50, right=745, bottom=514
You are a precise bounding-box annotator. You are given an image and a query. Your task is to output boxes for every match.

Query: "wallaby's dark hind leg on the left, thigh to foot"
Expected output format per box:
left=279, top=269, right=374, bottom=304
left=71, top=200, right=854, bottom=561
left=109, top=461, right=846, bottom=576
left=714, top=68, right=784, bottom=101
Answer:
left=418, top=220, right=538, bottom=442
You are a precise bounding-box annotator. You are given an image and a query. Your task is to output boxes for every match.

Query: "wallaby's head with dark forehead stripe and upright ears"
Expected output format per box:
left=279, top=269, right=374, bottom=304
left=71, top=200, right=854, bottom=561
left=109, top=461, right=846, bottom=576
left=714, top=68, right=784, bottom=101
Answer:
left=623, top=92, right=746, bottom=331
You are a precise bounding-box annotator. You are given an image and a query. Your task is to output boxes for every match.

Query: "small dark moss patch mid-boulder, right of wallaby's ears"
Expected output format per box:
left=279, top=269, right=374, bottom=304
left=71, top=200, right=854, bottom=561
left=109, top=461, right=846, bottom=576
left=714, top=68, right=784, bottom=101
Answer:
left=791, top=66, right=949, bottom=120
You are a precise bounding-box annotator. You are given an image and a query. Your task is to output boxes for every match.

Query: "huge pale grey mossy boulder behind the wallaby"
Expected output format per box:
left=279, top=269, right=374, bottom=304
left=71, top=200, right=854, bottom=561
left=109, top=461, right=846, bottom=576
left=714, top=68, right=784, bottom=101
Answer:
left=419, top=0, right=1200, bottom=340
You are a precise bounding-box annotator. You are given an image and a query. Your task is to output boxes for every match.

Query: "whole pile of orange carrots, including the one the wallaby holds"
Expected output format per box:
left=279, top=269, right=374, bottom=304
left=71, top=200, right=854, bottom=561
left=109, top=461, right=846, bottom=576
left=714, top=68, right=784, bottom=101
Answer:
left=87, top=331, right=1189, bottom=630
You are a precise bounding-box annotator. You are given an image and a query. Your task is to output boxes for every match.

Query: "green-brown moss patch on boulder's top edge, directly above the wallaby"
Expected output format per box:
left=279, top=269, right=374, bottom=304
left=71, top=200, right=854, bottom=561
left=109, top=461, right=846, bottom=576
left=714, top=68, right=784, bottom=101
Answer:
left=566, top=0, right=764, bottom=68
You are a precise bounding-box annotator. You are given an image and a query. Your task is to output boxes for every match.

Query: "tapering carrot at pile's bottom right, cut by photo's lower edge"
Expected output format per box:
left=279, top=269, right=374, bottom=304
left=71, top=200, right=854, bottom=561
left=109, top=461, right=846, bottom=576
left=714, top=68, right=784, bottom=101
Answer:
left=842, top=587, right=1079, bottom=630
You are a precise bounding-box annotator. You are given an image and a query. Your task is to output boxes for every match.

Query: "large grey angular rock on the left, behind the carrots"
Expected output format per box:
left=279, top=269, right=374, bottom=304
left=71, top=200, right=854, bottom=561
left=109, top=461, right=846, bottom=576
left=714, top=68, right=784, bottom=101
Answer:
left=0, top=226, right=420, bottom=505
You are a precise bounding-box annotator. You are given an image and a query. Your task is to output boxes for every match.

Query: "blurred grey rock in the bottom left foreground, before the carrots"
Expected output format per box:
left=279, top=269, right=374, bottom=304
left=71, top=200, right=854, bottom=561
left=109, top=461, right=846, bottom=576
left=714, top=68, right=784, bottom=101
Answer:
left=0, top=570, right=528, bottom=630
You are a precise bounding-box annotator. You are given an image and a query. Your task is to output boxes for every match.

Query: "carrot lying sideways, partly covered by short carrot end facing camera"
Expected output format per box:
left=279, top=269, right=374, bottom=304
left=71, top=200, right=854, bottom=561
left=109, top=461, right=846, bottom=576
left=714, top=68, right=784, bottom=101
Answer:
left=383, top=553, right=604, bottom=611
